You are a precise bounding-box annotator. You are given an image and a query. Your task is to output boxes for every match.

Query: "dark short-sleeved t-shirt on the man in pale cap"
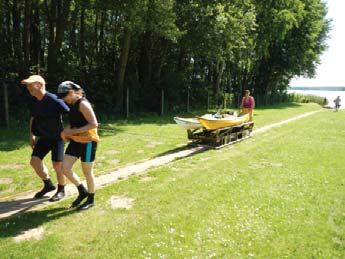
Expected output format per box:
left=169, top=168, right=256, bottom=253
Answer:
left=30, top=92, right=69, bottom=139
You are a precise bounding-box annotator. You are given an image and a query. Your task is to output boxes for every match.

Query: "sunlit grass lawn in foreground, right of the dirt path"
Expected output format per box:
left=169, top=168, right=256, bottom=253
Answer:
left=0, top=106, right=345, bottom=258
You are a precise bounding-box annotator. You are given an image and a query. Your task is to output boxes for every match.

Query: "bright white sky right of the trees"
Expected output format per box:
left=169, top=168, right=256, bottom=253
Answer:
left=290, top=0, right=345, bottom=86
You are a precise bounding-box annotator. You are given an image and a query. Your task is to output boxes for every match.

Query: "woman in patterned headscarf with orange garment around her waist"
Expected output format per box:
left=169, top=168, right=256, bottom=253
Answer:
left=57, top=81, right=99, bottom=210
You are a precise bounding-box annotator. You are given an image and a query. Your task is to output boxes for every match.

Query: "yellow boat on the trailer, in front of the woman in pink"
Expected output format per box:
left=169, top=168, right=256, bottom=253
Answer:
left=197, top=114, right=249, bottom=130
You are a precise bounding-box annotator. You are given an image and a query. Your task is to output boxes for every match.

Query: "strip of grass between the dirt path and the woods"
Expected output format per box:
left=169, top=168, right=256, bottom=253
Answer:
left=0, top=103, right=320, bottom=198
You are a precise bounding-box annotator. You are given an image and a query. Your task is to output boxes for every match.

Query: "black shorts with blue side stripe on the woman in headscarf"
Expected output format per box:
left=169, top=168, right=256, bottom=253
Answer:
left=66, top=140, right=97, bottom=162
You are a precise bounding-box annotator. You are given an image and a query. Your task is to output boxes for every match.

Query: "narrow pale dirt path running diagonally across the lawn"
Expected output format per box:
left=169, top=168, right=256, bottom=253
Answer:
left=0, top=110, right=322, bottom=219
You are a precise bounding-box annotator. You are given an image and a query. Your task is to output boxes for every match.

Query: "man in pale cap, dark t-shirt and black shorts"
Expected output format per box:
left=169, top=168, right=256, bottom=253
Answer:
left=21, top=75, right=69, bottom=201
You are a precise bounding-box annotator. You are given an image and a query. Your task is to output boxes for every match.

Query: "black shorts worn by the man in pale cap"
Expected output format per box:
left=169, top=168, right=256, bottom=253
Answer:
left=31, top=138, right=65, bottom=162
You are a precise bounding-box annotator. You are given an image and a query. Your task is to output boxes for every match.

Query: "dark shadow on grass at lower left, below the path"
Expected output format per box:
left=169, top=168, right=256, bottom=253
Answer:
left=0, top=208, right=77, bottom=238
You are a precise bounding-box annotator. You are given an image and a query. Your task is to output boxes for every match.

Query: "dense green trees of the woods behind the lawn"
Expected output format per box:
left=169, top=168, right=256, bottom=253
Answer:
left=0, top=0, right=330, bottom=122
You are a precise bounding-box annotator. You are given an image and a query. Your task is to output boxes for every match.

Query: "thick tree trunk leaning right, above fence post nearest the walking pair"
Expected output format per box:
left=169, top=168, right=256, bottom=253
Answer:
left=116, top=28, right=131, bottom=111
